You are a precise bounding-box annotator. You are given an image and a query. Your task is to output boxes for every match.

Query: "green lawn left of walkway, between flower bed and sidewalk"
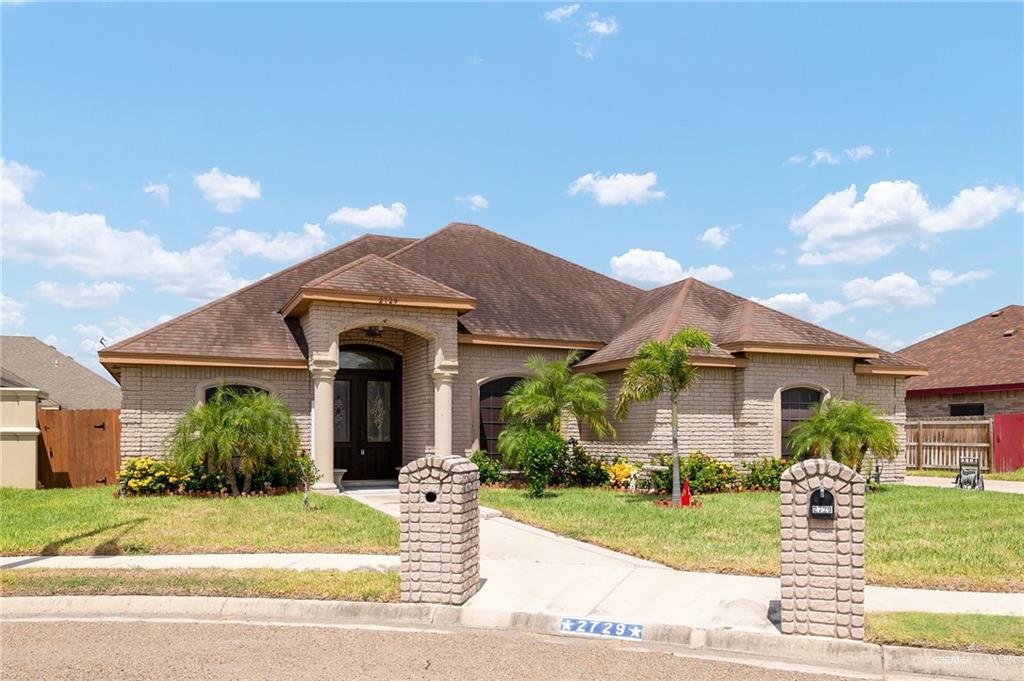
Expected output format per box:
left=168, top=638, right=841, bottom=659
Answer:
left=0, top=487, right=398, bottom=555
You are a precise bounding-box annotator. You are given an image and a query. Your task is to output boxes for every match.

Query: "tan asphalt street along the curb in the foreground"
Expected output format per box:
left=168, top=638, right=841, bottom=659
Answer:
left=0, top=621, right=856, bottom=681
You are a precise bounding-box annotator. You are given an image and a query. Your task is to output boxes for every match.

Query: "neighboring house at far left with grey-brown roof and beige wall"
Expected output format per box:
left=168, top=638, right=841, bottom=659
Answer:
left=0, top=336, right=121, bottom=490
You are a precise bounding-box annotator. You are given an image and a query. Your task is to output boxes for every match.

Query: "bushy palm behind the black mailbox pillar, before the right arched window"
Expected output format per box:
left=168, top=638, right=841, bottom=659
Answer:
left=788, top=397, right=899, bottom=473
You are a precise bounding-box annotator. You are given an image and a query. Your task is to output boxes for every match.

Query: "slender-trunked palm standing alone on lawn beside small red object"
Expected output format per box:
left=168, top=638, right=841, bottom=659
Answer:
left=615, top=328, right=711, bottom=506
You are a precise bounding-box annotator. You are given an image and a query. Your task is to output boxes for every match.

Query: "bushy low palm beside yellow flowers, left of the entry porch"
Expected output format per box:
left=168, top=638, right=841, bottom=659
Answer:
left=168, top=386, right=299, bottom=496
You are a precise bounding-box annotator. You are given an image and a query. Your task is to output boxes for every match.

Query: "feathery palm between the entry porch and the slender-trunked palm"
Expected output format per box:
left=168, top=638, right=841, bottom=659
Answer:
left=502, top=350, right=615, bottom=437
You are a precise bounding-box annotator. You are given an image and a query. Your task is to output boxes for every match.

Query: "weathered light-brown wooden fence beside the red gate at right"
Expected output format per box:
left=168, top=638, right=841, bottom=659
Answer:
left=906, top=419, right=992, bottom=471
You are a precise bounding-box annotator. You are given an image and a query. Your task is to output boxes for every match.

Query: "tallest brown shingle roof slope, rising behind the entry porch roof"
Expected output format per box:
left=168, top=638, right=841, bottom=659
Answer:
left=387, top=223, right=642, bottom=343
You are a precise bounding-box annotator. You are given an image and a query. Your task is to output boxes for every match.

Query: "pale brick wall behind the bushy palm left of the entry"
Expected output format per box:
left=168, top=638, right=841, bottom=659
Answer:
left=121, top=366, right=312, bottom=459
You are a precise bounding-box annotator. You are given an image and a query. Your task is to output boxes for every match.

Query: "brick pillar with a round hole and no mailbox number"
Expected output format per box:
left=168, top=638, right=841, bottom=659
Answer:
left=398, top=456, right=480, bottom=605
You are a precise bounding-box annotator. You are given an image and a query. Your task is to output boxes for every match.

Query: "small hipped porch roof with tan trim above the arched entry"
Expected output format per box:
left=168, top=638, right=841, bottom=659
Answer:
left=282, top=255, right=475, bottom=316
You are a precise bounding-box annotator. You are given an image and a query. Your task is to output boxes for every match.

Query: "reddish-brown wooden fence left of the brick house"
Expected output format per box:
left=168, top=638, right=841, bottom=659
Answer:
left=37, top=409, right=121, bottom=487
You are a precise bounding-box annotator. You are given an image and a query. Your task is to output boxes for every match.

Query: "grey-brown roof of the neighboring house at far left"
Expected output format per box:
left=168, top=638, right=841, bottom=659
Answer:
left=0, top=336, right=121, bottom=409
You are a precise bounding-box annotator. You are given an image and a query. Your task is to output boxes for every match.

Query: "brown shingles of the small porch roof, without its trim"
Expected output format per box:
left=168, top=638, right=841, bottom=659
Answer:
left=302, top=255, right=473, bottom=301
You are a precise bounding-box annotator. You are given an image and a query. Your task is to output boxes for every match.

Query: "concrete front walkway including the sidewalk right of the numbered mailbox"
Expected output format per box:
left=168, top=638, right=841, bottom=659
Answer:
left=346, top=490, right=1024, bottom=632
